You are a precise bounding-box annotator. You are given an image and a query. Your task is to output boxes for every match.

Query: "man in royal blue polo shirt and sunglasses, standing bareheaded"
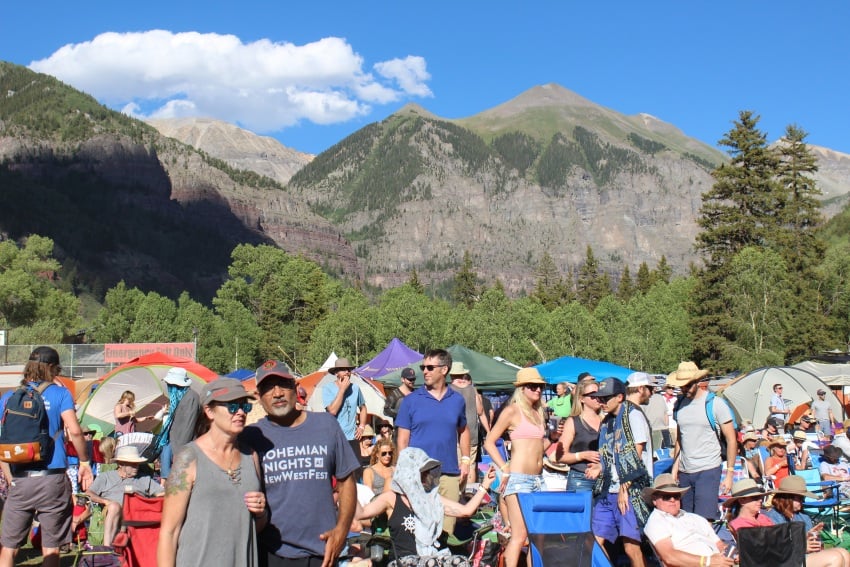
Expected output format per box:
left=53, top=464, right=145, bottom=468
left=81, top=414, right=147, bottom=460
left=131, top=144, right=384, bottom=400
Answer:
left=396, top=349, right=468, bottom=534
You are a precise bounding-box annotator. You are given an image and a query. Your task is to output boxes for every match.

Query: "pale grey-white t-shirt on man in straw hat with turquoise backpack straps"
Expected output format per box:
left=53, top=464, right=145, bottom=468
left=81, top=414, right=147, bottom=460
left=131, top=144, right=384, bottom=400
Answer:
left=676, top=394, right=732, bottom=473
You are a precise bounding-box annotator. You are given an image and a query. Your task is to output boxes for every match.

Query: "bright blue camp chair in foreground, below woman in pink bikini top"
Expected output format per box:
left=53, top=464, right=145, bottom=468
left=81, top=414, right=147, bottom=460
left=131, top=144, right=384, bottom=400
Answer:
left=517, top=491, right=611, bottom=567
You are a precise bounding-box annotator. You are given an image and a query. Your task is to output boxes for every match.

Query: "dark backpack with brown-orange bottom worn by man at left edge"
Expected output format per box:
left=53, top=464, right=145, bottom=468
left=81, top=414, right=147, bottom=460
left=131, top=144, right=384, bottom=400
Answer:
left=0, top=382, right=55, bottom=464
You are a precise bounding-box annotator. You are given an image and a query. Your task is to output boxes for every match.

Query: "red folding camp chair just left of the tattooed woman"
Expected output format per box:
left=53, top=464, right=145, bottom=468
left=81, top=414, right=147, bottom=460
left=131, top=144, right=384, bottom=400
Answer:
left=112, top=493, right=163, bottom=567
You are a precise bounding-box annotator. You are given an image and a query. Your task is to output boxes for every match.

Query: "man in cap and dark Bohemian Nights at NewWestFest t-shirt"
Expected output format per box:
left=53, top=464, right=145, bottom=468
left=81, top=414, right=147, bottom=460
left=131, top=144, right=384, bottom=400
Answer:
left=240, top=360, right=360, bottom=567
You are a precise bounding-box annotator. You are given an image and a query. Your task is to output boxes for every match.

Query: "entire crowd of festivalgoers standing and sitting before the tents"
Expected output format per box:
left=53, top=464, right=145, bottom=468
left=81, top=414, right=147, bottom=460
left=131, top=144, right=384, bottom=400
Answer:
left=0, top=347, right=850, bottom=567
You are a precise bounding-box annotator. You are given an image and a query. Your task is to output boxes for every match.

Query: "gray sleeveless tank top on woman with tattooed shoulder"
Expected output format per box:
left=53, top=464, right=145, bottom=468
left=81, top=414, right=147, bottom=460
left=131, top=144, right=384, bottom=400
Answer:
left=177, top=442, right=260, bottom=567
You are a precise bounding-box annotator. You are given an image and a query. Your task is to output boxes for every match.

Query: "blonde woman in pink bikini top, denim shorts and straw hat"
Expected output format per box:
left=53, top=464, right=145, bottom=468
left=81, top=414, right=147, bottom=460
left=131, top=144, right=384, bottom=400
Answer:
left=484, top=368, right=549, bottom=567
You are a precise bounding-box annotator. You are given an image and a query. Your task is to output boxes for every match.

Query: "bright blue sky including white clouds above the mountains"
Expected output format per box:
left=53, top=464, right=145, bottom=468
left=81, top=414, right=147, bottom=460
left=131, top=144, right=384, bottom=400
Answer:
left=0, top=0, right=850, bottom=153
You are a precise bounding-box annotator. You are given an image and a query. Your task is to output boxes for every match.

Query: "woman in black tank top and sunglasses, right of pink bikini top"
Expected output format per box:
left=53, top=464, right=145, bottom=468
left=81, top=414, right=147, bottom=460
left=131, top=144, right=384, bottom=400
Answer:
left=555, top=381, right=602, bottom=492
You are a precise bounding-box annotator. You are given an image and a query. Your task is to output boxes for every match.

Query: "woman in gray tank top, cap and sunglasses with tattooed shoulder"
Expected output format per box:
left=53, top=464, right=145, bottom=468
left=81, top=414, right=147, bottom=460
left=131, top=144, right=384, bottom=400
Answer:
left=157, top=378, right=268, bottom=567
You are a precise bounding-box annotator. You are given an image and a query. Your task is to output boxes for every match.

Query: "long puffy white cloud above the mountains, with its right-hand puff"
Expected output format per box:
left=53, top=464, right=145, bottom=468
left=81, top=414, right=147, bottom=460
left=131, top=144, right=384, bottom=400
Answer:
left=30, top=30, right=432, bottom=133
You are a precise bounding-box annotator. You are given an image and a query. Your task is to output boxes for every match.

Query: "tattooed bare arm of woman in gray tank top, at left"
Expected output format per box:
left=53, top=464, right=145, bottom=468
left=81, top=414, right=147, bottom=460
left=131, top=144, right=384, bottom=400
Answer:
left=156, top=447, right=197, bottom=567
